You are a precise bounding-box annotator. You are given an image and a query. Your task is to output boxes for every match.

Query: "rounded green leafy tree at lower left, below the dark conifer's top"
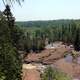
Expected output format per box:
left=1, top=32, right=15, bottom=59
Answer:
left=0, top=42, right=22, bottom=80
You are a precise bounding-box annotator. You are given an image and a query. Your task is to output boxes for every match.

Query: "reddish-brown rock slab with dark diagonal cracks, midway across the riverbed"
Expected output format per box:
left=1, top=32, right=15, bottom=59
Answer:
left=24, top=45, right=68, bottom=64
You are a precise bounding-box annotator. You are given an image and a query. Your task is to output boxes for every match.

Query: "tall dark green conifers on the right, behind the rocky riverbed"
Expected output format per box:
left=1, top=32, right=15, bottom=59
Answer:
left=40, top=21, right=80, bottom=51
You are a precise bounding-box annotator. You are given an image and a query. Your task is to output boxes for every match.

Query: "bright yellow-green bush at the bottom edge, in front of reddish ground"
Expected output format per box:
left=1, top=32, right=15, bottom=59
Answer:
left=42, top=67, right=72, bottom=80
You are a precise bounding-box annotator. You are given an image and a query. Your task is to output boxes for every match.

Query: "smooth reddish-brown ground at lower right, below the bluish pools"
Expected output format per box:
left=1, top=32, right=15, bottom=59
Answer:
left=54, top=59, right=80, bottom=78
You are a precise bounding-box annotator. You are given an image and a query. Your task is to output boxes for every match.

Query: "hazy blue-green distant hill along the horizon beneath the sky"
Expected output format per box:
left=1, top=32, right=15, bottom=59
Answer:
left=16, top=20, right=80, bottom=28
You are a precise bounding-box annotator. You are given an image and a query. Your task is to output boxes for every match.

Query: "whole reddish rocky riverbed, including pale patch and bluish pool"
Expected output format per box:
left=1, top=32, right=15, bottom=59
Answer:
left=23, top=43, right=80, bottom=80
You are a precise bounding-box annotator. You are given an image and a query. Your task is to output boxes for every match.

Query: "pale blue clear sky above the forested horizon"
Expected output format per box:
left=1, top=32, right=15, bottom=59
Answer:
left=0, top=0, right=80, bottom=21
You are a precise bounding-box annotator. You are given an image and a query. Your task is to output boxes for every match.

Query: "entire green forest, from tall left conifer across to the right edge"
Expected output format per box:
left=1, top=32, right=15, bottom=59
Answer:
left=0, top=5, right=80, bottom=80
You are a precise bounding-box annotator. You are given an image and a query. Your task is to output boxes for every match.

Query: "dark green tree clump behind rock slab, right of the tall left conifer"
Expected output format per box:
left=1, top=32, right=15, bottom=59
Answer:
left=18, top=30, right=45, bottom=53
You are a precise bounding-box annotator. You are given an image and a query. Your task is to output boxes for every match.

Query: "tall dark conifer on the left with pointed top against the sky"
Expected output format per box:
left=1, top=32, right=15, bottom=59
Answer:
left=0, top=6, right=22, bottom=80
